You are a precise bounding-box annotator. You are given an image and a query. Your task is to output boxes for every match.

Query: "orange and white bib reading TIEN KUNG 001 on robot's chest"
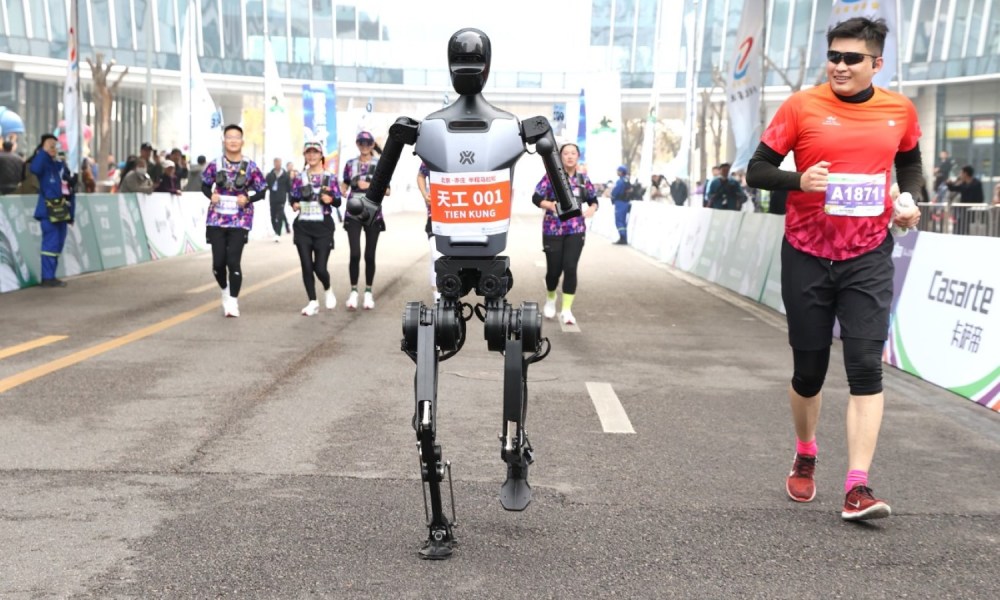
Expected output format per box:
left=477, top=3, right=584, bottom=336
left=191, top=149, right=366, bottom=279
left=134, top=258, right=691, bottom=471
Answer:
left=429, top=169, right=511, bottom=237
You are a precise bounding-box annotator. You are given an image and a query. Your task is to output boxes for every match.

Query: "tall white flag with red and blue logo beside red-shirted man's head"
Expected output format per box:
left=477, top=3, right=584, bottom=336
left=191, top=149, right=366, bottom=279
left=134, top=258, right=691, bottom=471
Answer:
left=726, top=0, right=765, bottom=171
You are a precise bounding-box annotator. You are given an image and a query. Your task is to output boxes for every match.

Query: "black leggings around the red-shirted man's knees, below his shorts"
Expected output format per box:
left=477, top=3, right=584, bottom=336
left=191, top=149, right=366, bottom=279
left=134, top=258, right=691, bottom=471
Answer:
left=792, top=338, right=885, bottom=398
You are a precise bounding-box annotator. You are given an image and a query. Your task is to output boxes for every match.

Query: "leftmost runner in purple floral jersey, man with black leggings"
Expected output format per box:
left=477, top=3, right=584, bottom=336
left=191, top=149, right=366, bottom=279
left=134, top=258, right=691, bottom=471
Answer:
left=201, top=125, right=267, bottom=317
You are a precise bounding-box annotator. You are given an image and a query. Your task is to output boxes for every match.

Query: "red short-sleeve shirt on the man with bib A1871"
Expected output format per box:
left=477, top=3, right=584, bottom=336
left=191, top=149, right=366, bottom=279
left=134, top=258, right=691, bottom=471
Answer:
left=761, top=85, right=920, bottom=260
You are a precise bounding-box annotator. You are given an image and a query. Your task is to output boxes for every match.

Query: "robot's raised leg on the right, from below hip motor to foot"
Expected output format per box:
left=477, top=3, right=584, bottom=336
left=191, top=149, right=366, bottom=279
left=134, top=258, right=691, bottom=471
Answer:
left=500, top=339, right=534, bottom=510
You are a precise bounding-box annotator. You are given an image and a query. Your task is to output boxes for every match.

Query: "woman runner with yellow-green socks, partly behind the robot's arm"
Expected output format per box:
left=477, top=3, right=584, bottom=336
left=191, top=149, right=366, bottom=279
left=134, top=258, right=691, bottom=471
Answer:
left=531, top=144, right=597, bottom=325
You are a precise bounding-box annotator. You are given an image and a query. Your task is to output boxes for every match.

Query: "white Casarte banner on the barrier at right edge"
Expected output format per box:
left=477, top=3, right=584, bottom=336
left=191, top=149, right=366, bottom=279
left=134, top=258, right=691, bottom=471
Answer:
left=891, top=232, right=1000, bottom=407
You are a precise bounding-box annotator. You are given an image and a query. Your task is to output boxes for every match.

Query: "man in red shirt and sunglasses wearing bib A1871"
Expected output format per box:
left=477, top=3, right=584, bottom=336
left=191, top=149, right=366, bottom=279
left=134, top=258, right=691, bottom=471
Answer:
left=747, top=17, right=923, bottom=520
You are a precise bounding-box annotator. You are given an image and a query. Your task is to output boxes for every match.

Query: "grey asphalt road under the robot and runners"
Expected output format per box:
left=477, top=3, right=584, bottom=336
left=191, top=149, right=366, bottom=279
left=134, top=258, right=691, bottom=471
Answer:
left=0, top=213, right=1000, bottom=599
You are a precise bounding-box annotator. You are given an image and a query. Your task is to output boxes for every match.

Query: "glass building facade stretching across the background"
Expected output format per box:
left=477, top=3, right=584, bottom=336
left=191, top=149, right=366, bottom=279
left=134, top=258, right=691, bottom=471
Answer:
left=0, top=0, right=1000, bottom=185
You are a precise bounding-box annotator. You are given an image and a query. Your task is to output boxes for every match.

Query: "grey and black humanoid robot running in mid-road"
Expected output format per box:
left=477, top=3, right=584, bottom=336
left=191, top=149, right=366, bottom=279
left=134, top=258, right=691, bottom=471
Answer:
left=347, top=29, right=580, bottom=559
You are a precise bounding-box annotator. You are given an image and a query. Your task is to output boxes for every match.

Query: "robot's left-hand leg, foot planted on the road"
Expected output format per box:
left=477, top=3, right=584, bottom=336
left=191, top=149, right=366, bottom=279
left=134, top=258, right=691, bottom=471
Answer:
left=403, top=302, right=455, bottom=560
